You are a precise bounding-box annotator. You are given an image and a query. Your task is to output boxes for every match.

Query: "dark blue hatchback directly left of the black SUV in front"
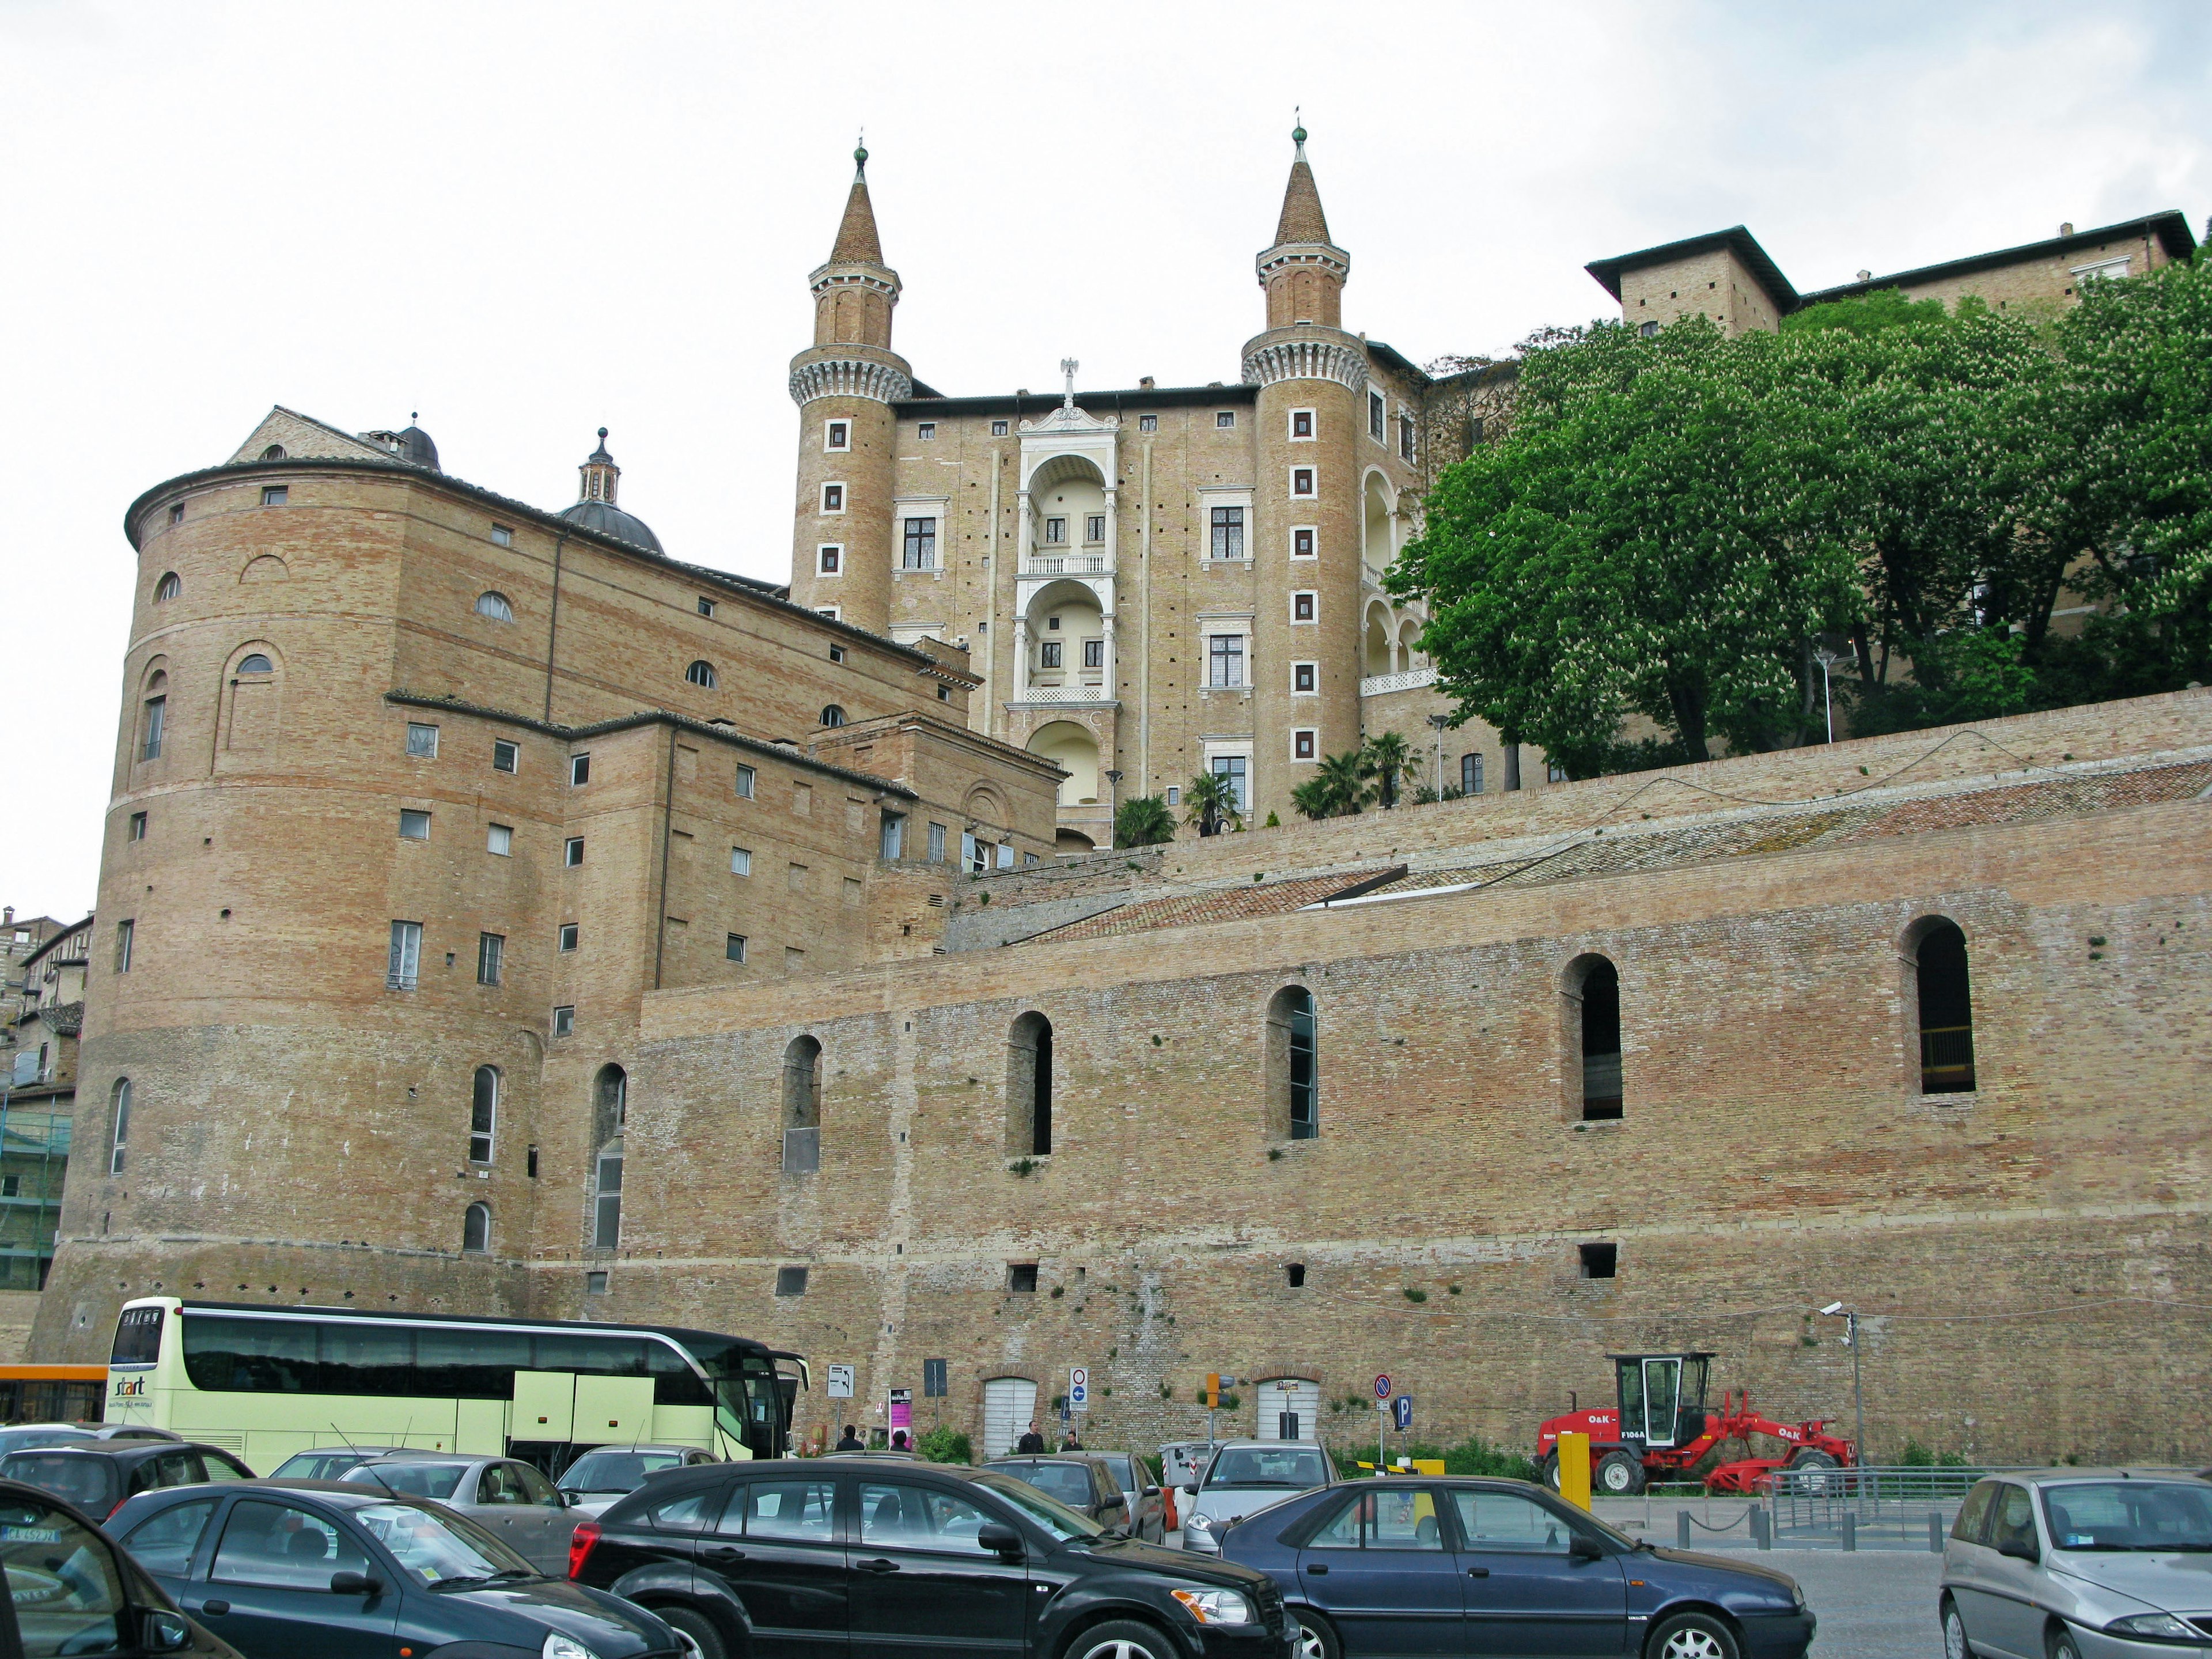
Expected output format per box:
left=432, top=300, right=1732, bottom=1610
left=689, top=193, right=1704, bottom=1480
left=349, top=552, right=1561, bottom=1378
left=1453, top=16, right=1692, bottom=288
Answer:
left=106, top=1480, right=688, bottom=1659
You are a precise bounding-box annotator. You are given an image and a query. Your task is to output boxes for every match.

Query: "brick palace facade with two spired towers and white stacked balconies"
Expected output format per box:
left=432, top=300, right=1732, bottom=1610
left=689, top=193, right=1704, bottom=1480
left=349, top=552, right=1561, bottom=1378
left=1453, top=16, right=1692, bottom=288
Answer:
left=790, top=128, right=1442, bottom=854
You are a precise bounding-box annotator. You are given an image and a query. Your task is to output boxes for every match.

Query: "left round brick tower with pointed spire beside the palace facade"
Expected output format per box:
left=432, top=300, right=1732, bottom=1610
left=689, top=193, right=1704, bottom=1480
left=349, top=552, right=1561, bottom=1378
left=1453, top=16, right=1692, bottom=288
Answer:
left=792, top=150, right=914, bottom=632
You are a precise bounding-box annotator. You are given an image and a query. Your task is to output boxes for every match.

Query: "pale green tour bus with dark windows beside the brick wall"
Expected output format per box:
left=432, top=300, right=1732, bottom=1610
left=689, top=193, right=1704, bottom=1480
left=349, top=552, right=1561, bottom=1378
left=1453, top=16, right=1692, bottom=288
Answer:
left=106, top=1296, right=808, bottom=1471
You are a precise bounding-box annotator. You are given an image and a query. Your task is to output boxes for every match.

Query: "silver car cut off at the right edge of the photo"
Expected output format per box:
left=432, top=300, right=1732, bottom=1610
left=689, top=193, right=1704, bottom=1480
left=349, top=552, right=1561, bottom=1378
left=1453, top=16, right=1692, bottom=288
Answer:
left=1938, top=1469, right=2212, bottom=1659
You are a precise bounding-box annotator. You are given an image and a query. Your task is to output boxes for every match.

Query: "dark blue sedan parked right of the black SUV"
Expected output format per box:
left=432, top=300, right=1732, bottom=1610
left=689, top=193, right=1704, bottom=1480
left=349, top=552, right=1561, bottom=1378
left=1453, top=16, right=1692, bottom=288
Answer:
left=1221, top=1478, right=1814, bottom=1659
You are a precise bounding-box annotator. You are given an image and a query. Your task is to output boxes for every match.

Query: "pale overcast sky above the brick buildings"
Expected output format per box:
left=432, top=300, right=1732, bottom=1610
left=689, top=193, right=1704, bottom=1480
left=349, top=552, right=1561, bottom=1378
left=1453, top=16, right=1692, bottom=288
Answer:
left=0, top=0, right=2212, bottom=918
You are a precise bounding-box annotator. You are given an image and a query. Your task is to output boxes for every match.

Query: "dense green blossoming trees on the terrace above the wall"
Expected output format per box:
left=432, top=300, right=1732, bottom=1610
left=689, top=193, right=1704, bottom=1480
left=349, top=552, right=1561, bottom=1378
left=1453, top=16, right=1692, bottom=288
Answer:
left=1387, top=263, right=2212, bottom=777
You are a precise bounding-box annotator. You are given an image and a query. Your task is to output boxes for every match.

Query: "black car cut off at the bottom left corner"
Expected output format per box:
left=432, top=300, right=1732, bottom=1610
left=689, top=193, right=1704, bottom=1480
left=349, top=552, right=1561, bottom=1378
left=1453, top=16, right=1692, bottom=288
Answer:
left=0, top=1480, right=241, bottom=1659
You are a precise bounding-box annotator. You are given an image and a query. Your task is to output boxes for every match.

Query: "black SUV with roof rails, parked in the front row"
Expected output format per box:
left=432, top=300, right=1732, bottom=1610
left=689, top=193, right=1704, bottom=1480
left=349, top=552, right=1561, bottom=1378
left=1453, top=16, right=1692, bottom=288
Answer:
left=569, top=1456, right=1294, bottom=1659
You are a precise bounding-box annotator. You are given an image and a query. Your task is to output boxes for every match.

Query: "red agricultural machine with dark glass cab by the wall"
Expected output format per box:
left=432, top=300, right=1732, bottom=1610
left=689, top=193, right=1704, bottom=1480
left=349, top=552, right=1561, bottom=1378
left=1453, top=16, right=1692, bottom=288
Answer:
left=1535, top=1354, right=1858, bottom=1498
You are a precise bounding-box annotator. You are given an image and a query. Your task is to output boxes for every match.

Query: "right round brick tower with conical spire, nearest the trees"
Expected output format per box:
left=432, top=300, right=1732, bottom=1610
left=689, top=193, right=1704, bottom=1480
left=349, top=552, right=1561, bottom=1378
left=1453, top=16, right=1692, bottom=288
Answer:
left=1243, top=126, right=1367, bottom=819
